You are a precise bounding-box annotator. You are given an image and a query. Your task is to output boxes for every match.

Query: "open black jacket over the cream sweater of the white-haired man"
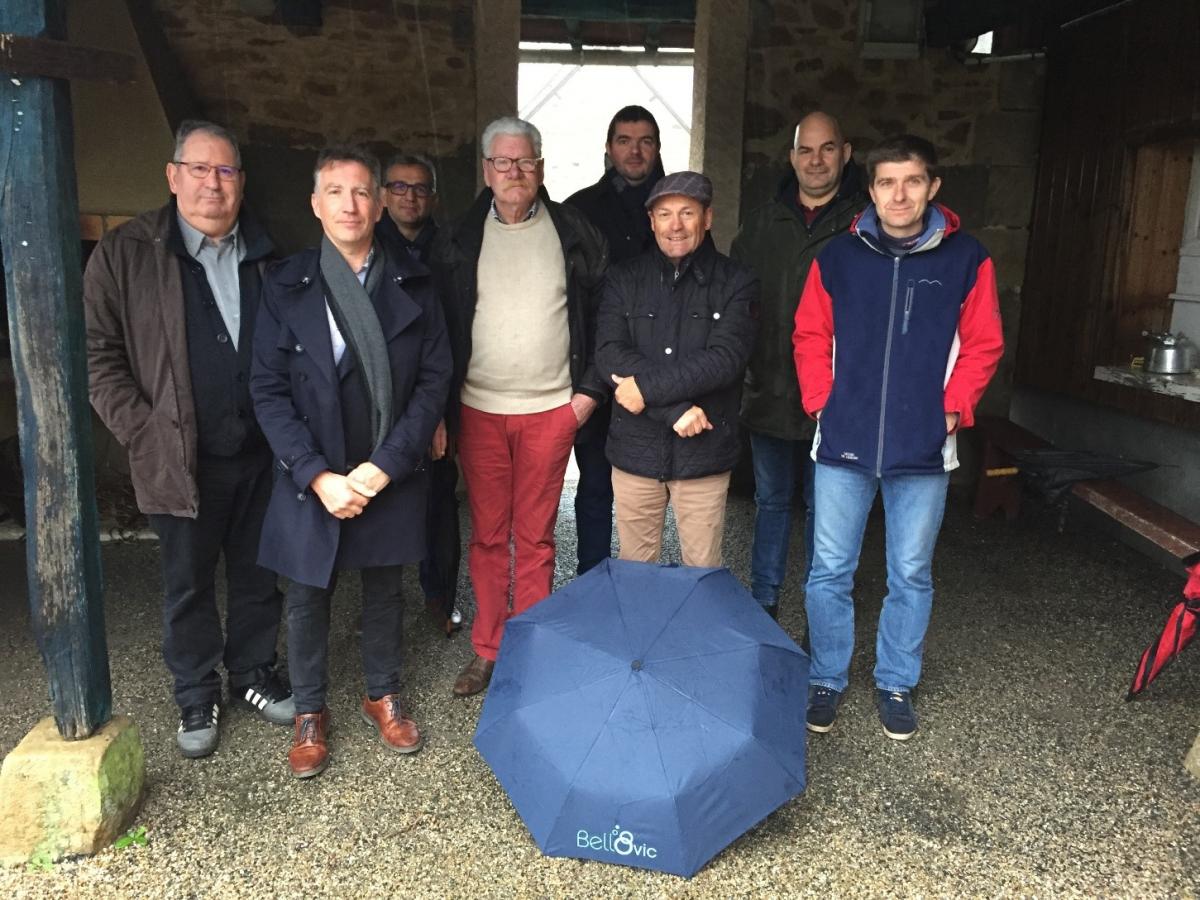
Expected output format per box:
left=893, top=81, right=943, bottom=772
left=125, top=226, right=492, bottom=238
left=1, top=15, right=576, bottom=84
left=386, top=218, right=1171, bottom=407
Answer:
left=430, top=187, right=610, bottom=433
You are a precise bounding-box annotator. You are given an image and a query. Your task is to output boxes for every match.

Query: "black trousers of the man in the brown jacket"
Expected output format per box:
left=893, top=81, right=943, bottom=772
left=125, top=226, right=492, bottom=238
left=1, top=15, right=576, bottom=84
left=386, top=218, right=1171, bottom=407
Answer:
left=149, top=452, right=282, bottom=707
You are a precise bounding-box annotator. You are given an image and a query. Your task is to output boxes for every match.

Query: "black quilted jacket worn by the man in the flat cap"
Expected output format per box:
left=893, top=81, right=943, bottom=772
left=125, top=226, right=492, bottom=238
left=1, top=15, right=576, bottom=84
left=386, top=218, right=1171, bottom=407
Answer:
left=596, top=236, right=758, bottom=481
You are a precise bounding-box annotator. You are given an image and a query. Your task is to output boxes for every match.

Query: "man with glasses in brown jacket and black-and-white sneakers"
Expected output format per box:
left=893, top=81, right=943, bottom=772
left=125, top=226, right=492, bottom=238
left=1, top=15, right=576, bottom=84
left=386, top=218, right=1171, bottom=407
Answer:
left=84, top=121, right=295, bottom=757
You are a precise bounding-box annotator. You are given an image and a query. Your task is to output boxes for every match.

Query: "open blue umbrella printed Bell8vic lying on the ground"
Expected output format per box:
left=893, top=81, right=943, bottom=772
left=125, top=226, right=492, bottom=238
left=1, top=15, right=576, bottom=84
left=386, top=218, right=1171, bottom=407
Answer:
left=475, top=559, right=809, bottom=876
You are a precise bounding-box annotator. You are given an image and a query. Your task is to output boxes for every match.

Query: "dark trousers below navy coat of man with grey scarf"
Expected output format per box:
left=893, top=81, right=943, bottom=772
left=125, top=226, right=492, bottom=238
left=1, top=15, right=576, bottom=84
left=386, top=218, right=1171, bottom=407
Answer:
left=287, top=565, right=404, bottom=715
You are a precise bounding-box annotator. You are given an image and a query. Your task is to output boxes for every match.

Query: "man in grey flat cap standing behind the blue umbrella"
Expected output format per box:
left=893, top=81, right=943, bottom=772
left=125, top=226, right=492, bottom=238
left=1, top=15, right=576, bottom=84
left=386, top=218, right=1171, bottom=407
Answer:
left=596, top=172, right=758, bottom=566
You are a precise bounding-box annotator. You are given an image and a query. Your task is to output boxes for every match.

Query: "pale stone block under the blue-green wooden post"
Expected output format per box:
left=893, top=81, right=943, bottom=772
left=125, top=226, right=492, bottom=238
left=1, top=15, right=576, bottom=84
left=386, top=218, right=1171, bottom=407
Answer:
left=0, top=715, right=145, bottom=865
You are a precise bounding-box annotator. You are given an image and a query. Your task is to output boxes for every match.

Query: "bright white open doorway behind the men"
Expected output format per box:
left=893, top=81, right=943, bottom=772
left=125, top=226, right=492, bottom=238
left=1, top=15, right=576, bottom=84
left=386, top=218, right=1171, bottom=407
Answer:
left=517, top=42, right=692, bottom=200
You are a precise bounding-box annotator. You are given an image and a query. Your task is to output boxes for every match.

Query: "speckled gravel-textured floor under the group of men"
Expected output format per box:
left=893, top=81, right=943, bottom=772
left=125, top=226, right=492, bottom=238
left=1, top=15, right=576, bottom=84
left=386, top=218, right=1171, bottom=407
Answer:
left=0, top=497, right=1200, bottom=898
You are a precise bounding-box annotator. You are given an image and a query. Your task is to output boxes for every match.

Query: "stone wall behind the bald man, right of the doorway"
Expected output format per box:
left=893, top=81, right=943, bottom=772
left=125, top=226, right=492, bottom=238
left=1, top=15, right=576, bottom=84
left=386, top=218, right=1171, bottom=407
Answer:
left=742, top=0, right=1043, bottom=427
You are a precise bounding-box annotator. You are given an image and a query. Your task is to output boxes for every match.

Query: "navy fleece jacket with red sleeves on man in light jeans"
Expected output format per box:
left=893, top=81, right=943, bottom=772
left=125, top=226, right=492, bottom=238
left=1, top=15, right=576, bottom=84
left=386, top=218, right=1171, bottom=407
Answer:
left=792, top=204, right=1004, bottom=476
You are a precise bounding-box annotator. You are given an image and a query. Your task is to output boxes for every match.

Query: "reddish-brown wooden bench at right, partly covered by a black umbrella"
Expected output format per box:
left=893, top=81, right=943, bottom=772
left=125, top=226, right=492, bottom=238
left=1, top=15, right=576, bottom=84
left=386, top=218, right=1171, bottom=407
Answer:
left=974, top=415, right=1200, bottom=559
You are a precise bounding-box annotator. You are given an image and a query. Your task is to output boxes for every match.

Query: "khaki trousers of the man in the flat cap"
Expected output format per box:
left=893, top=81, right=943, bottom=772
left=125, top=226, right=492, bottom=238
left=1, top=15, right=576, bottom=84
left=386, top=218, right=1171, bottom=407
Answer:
left=612, top=466, right=731, bottom=568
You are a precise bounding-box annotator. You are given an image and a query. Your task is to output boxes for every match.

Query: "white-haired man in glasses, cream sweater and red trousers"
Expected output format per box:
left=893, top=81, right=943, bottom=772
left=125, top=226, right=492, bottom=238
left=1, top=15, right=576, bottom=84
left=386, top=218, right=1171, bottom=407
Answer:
left=432, top=118, right=608, bottom=696
